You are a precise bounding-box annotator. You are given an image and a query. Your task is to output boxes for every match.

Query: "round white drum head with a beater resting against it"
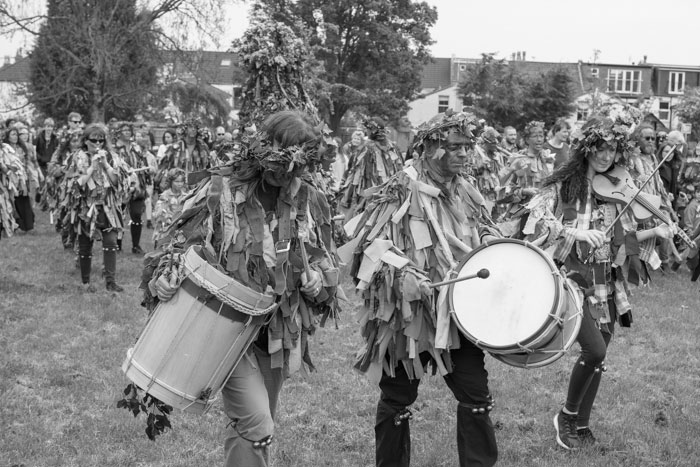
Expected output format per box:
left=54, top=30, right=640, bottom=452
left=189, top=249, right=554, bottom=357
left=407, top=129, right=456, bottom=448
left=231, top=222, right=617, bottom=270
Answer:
left=450, top=240, right=561, bottom=350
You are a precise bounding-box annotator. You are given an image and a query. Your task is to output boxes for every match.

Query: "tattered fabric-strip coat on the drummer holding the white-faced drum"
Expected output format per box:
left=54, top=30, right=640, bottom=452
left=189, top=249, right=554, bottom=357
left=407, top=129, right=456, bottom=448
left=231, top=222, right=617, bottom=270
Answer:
left=348, top=160, right=500, bottom=381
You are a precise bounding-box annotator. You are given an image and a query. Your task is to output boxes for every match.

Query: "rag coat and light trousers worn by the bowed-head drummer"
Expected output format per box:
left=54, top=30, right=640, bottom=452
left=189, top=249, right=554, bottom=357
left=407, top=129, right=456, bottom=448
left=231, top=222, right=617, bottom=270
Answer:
left=144, top=154, right=338, bottom=467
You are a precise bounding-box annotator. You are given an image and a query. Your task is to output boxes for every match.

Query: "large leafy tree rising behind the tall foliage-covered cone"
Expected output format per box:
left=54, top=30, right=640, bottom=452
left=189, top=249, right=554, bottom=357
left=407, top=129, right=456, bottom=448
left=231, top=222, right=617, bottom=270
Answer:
left=252, top=0, right=437, bottom=131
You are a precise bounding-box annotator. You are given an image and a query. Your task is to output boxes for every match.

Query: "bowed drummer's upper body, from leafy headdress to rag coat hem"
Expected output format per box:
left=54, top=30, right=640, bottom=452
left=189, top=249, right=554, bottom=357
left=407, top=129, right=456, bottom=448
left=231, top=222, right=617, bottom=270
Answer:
left=143, top=111, right=339, bottom=372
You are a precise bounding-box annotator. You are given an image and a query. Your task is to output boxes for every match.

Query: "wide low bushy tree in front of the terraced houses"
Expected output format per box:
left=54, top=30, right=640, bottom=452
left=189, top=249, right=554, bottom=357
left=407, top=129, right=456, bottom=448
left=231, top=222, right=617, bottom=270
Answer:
left=459, top=54, right=574, bottom=132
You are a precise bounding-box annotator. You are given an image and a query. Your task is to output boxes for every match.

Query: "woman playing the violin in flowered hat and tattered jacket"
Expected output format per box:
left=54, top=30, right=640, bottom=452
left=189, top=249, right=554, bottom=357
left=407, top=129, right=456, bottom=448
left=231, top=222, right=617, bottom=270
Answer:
left=523, top=115, right=672, bottom=450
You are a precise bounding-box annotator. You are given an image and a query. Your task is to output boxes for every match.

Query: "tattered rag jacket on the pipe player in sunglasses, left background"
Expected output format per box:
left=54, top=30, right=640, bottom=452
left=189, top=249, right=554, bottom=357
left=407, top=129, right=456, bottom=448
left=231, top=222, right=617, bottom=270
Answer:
left=64, top=151, right=129, bottom=240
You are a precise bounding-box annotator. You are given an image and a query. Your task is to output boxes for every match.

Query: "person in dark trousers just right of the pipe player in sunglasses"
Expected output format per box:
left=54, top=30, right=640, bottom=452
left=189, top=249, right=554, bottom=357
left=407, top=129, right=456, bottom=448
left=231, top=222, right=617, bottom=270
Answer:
left=115, top=122, right=156, bottom=255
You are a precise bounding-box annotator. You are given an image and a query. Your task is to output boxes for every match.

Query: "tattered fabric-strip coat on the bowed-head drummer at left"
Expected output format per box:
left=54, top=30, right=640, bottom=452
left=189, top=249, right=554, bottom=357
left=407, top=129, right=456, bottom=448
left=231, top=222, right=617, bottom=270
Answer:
left=148, top=170, right=339, bottom=374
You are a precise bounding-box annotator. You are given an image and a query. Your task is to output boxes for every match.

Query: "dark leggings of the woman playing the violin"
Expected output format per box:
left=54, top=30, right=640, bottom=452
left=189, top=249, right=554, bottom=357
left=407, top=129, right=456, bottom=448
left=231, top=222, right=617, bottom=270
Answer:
left=565, top=298, right=617, bottom=426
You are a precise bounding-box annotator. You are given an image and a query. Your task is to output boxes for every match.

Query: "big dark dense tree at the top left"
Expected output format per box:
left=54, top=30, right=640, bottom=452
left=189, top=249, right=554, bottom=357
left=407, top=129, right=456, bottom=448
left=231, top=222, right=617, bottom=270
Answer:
left=29, top=0, right=157, bottom=121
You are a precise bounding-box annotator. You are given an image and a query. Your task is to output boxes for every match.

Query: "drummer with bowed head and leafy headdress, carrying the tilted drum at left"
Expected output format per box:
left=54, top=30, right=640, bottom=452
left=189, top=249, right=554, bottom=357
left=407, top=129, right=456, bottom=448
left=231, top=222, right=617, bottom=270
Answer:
left=145, top=111, right=338, bottom=467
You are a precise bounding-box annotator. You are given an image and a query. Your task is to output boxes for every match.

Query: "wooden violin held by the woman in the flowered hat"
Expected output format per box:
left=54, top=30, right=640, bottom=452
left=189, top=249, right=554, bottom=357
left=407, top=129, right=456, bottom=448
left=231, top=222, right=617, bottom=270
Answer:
left=591, top=166, right=697, bottom=248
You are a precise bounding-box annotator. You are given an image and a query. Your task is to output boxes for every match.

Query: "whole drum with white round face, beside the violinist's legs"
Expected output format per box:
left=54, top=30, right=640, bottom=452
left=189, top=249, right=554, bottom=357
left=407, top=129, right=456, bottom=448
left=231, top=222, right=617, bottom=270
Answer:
left=448, top=239, right=582, bottom=368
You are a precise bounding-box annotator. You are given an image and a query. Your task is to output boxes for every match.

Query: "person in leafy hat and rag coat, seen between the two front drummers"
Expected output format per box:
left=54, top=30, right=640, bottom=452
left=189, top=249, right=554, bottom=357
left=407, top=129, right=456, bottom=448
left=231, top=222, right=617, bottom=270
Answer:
left=339, top=117, right=403, bottom=218
